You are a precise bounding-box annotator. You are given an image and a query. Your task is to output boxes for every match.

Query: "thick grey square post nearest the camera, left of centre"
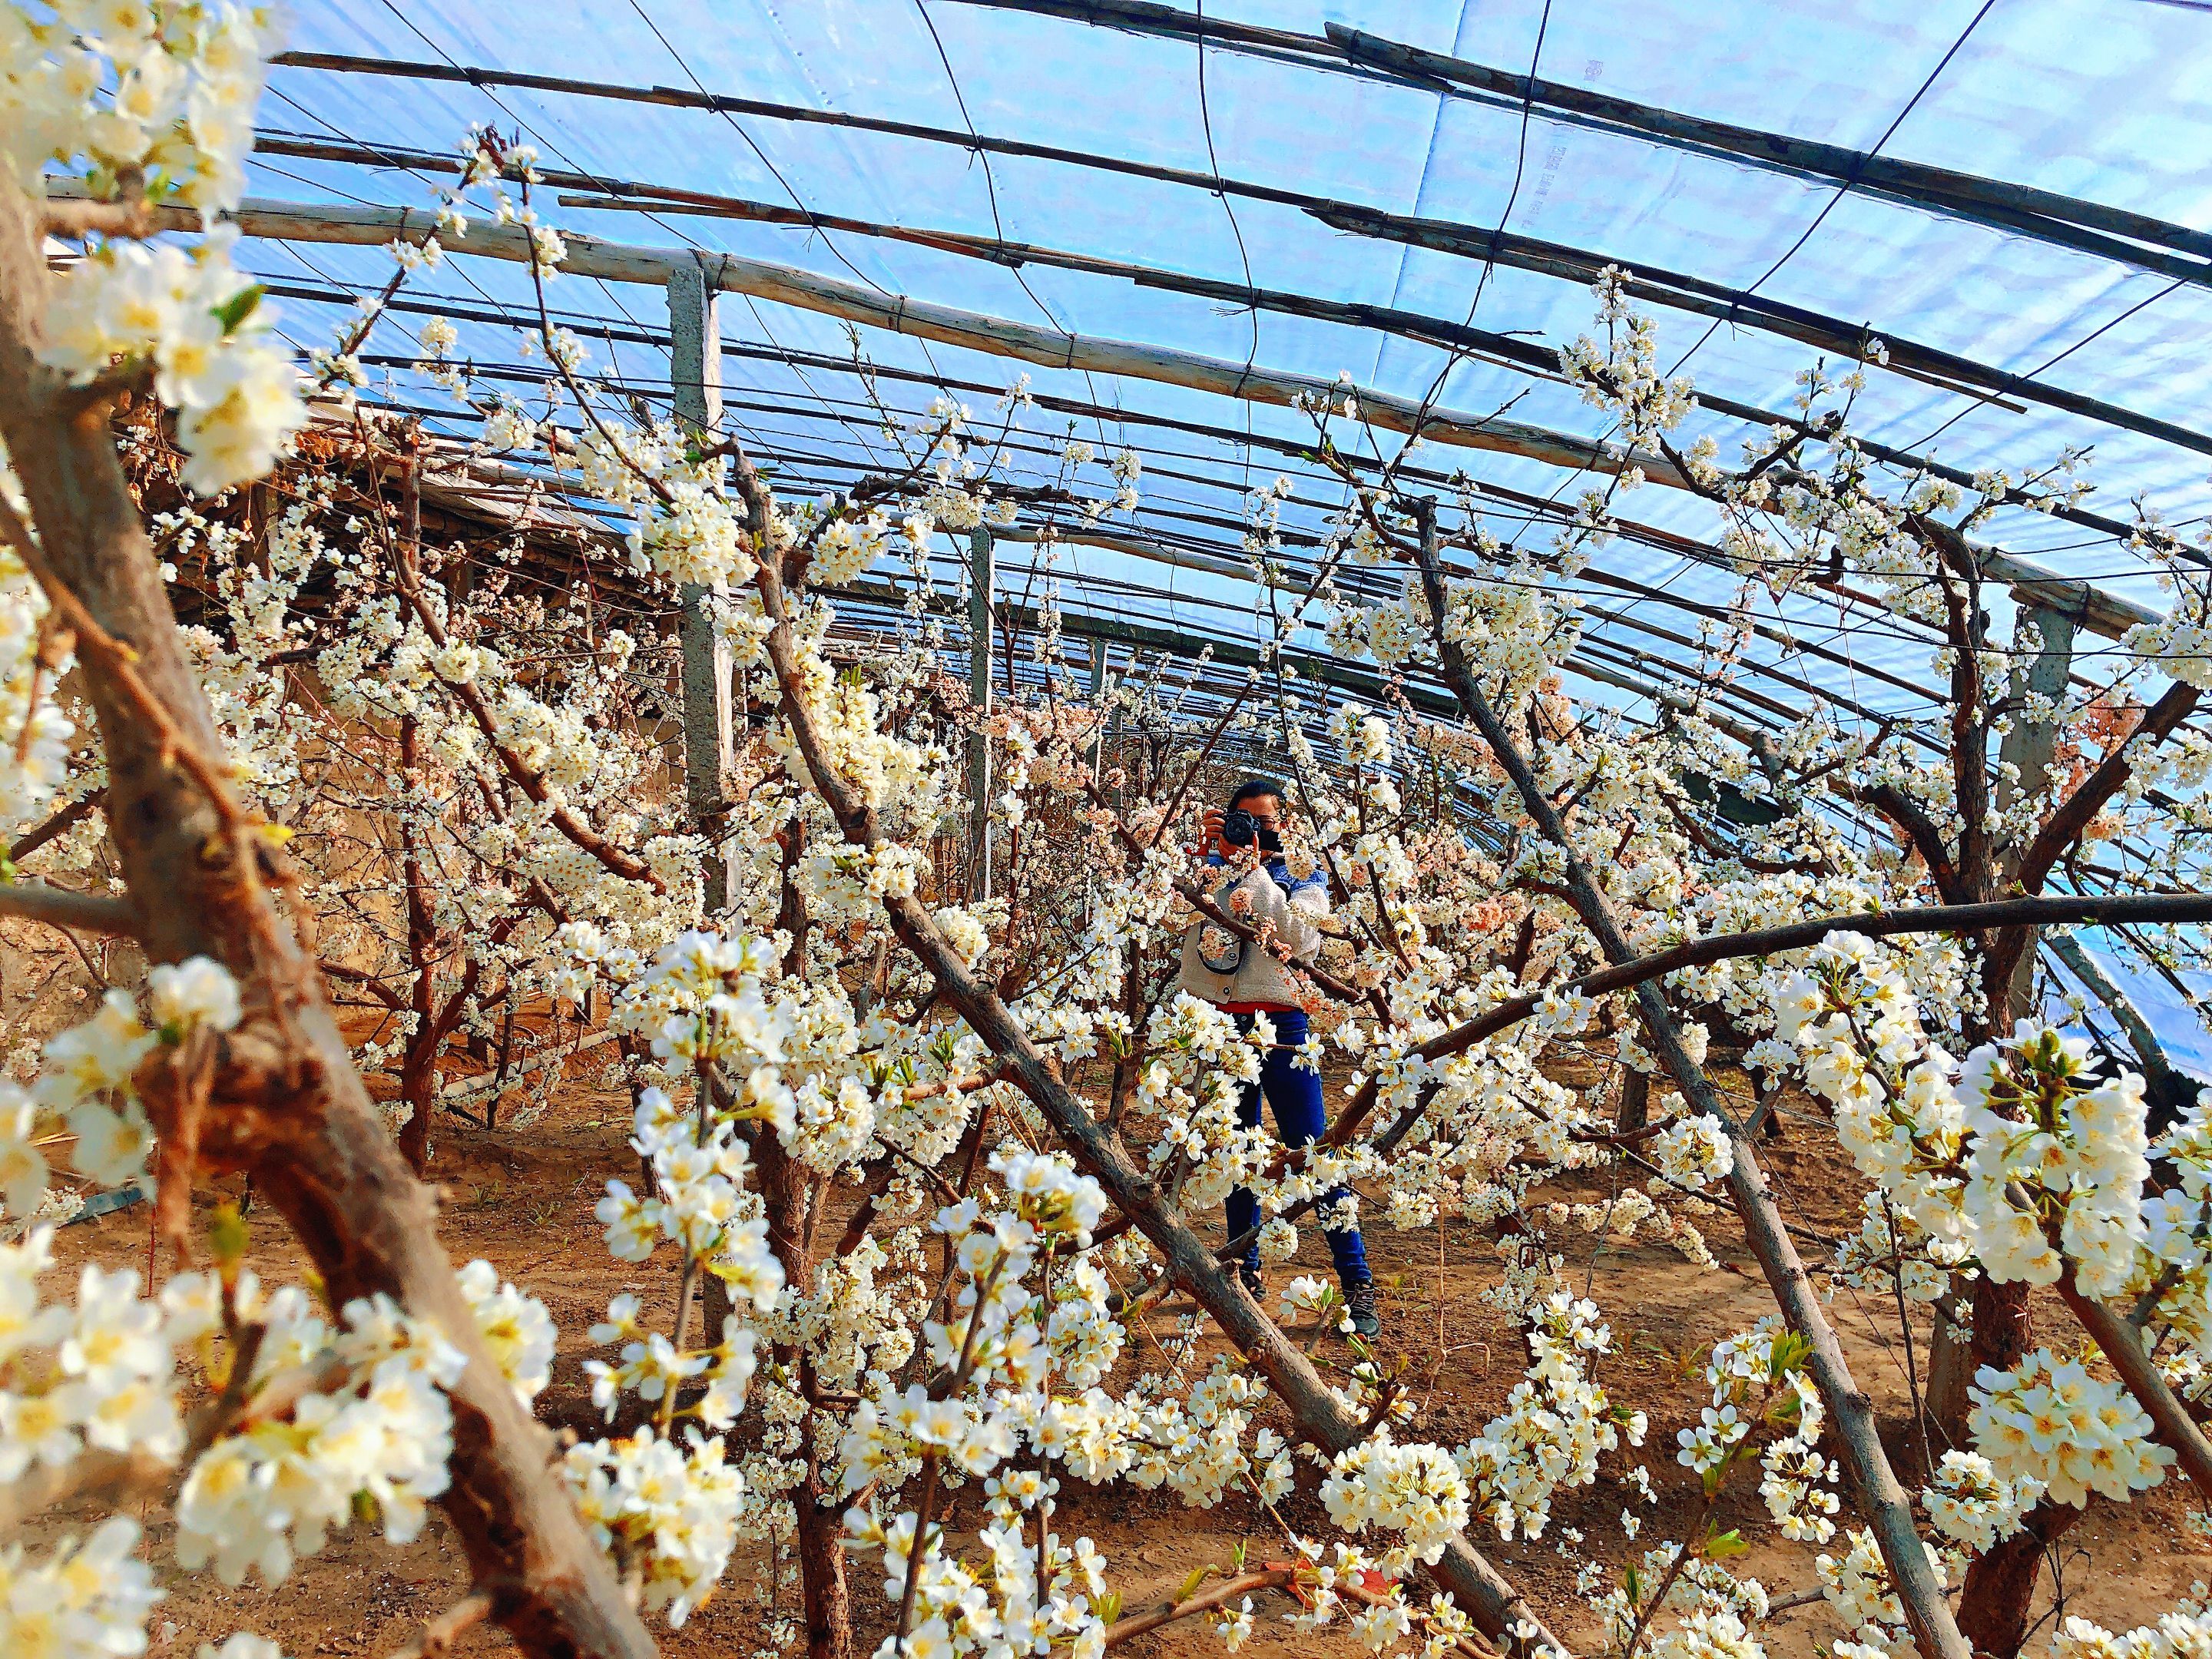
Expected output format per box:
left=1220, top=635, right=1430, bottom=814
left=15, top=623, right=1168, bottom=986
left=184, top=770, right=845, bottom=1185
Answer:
left=668, top=266, right=737, bottom=913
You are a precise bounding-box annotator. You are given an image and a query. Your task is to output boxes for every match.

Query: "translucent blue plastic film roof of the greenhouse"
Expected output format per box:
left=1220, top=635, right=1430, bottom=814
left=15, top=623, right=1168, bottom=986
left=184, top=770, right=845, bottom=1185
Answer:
left=224, top=0, right=2212, bottom=752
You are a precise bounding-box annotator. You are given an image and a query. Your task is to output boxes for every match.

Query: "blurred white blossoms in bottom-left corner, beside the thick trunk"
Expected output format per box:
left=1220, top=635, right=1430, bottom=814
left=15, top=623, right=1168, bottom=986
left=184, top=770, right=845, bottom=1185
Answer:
left=0, top=1226, right=551, bottom=1659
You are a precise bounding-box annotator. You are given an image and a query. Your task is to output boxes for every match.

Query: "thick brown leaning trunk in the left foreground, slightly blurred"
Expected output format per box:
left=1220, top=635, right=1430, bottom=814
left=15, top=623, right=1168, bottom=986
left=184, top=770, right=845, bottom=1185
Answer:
left=0, top=186, right=654, bottom=1659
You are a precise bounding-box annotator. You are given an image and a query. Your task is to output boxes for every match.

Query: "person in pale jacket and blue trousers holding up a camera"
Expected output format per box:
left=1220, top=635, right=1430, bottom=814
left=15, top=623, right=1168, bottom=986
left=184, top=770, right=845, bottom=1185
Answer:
left=1181, top=779, right=1382, bottom=1338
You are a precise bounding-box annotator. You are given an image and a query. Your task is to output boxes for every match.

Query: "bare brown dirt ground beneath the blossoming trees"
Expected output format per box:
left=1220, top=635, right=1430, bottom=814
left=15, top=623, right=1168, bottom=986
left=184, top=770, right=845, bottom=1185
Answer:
left=25, top=1057, right=2212, bottom=1659
